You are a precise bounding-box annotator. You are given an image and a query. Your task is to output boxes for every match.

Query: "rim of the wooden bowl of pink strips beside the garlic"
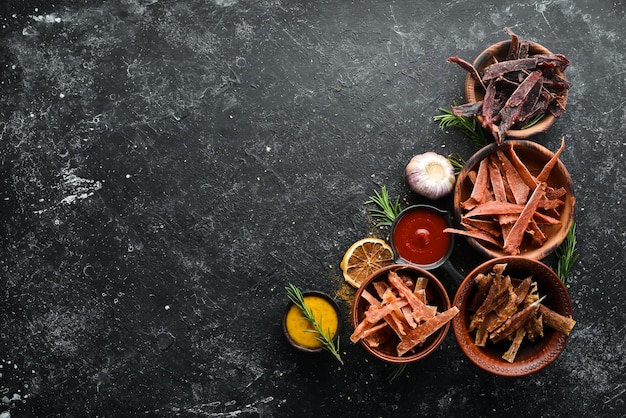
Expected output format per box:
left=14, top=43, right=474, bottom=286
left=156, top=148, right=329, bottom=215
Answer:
left=453, top=139, right=576, bottom=260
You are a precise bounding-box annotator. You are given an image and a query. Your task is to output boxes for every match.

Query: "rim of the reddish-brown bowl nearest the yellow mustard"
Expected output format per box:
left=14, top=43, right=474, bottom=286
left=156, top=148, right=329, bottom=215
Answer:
left=352, top=263, right=452, bottom=364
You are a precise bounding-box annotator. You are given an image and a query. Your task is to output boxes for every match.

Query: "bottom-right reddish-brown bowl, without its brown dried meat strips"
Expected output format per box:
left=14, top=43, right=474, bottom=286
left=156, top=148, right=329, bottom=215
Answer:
left=452, top=257, right=572, bottom=377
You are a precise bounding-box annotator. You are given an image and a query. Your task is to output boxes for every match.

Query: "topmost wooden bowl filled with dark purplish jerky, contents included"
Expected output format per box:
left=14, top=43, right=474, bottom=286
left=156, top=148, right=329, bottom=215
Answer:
left=448, top=28, right=570, bottom=144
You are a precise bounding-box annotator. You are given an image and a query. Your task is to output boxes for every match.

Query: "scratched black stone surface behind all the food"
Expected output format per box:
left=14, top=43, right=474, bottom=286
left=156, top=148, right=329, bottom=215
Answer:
left=0, top=0, right=626, bottom=418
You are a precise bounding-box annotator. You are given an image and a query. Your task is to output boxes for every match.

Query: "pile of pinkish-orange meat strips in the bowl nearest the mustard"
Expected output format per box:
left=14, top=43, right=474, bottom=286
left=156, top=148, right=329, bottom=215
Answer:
left=350, top=270, right=459, bottom=357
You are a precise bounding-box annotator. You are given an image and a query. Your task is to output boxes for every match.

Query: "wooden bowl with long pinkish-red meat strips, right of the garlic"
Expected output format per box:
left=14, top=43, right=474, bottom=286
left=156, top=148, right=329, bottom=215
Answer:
left=446, top=140, right=576, bottom=260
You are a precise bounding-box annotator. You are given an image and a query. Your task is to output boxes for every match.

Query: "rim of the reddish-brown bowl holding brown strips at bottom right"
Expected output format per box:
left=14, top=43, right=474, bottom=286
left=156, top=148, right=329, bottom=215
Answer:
left=451, top=256, right=573, bottom=377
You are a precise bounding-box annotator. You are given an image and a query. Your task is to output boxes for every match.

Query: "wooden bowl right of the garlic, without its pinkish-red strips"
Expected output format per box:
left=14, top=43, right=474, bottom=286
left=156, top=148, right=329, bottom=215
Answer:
left=454, top=140, right=576, bottom=260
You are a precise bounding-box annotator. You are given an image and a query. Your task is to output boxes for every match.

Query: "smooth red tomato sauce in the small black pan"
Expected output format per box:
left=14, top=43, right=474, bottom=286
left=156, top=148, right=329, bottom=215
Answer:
left=391, top=208, right=451, bottom=265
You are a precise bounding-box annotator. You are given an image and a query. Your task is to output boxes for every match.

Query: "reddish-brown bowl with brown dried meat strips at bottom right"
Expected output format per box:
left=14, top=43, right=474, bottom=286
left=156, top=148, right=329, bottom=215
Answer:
left=452, top=256, right=576, bottom=377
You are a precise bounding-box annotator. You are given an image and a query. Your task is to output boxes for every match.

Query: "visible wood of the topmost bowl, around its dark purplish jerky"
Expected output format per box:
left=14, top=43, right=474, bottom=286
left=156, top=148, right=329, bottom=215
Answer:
left=465, top=40, right=567, bottom=139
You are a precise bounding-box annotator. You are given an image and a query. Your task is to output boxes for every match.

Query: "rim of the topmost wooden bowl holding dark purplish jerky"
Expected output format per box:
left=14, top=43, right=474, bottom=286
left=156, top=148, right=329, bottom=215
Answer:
left=465, top=39, right=569, bottom=139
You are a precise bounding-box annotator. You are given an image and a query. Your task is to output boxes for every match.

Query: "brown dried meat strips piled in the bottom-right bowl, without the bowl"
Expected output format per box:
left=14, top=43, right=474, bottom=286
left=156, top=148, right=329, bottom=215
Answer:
left=468, top=264, right=576, bottom=363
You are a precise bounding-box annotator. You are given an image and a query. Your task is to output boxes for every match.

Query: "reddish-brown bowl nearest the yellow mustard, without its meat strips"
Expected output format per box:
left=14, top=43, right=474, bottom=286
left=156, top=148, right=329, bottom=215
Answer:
left=352, top=264, right=451, bottom=364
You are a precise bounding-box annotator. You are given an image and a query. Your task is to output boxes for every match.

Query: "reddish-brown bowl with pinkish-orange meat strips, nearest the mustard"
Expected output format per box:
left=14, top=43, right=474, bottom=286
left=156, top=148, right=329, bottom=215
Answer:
left=350, top=264, right=458, bottom=364
